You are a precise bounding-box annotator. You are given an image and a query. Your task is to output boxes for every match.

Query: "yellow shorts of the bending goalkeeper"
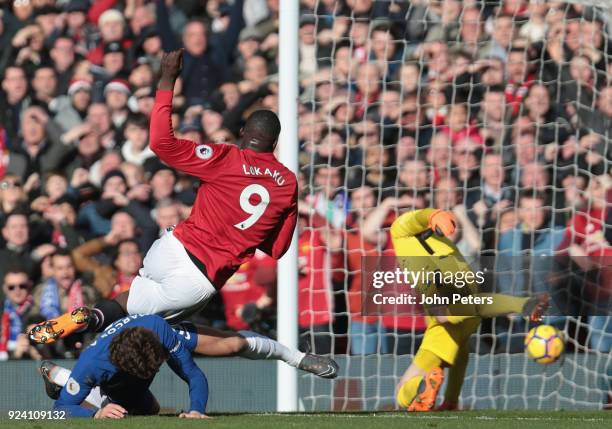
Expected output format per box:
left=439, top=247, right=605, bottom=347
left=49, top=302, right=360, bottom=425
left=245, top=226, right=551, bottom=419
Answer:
left=421, top=316, right=480, bottom=365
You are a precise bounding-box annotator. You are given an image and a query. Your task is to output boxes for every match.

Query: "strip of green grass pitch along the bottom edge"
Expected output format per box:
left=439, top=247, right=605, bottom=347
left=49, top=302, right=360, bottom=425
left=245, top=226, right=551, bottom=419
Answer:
left=0, top=411, right=612, bottom=429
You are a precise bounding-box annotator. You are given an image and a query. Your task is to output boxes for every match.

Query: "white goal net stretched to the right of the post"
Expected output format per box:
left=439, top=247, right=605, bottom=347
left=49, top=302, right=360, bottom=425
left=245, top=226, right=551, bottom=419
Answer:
left=296, top=0, right=612, bottom=410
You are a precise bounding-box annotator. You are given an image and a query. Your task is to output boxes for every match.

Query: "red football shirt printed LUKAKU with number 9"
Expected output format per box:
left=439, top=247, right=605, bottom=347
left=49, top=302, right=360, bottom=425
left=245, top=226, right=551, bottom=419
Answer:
left=150, top=90, right=297, bottom=288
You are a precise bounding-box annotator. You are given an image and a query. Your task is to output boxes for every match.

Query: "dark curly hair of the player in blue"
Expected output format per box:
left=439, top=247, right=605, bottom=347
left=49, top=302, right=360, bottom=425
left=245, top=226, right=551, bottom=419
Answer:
left=109, top=326, right=168, bottom=380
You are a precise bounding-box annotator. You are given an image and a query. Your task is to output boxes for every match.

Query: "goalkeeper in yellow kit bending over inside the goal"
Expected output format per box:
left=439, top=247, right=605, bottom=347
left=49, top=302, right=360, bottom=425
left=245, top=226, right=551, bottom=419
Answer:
left=391, top=209, right=549, bottom=411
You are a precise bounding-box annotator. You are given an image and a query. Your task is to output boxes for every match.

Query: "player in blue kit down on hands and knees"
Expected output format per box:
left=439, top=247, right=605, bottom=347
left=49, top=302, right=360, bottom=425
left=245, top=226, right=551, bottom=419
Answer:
left=40, top=315, right=336, bottom=418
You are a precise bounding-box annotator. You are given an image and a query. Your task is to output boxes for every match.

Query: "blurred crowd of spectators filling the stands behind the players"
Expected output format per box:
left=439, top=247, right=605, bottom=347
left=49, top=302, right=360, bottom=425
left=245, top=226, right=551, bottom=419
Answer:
left=0, top=0, right=612, bottom=359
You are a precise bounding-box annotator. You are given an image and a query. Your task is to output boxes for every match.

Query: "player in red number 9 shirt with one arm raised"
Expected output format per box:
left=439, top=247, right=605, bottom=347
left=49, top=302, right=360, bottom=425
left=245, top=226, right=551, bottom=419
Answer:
left=30, top=50, right=340, bottom=378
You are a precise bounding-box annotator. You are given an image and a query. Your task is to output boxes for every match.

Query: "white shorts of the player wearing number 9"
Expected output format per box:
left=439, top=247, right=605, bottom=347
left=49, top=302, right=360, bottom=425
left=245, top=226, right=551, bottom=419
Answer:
left=127, top=230, right=217, bottom=322
